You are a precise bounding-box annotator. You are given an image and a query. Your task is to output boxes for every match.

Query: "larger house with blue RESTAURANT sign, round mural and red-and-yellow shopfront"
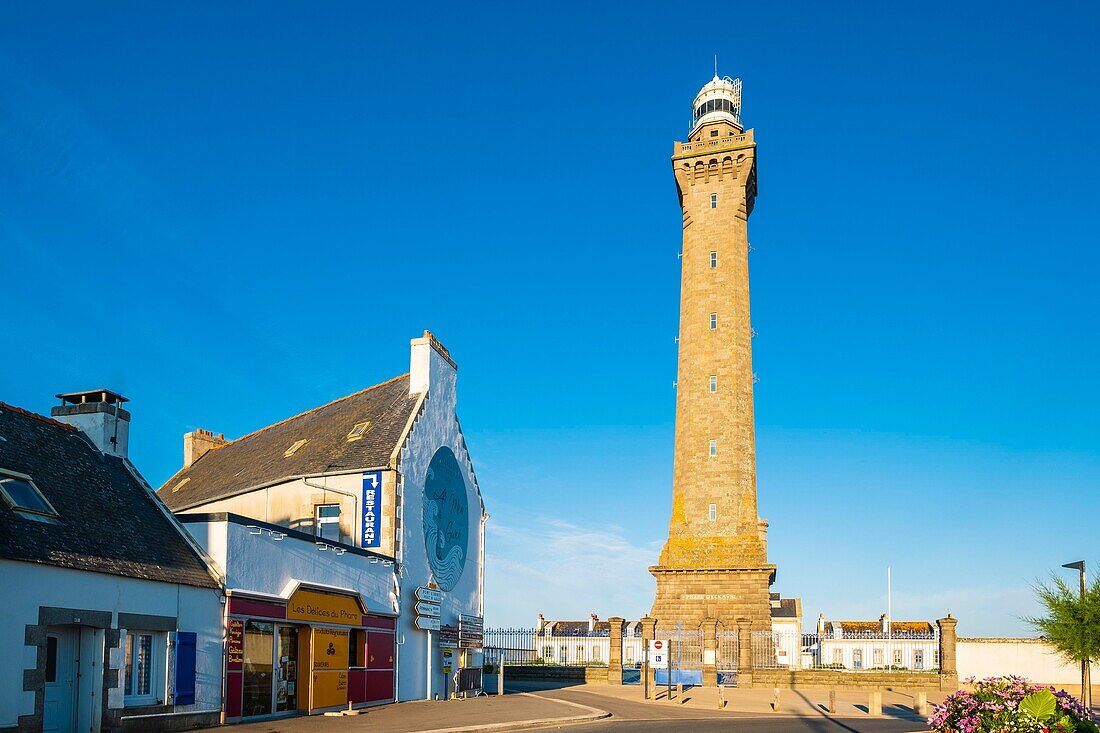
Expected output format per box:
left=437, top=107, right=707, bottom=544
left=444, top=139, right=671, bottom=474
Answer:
left=158, top=331, right=488, bottom=721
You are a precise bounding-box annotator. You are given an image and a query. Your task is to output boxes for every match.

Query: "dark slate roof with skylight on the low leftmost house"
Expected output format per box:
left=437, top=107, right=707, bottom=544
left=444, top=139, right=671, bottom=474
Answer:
left=0, top=403, right=218, bottom=591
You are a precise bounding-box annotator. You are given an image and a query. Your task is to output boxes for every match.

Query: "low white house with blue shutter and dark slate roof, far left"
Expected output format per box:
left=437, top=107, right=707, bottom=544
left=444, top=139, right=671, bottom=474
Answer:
left=0, top=390, right=224, bottom=733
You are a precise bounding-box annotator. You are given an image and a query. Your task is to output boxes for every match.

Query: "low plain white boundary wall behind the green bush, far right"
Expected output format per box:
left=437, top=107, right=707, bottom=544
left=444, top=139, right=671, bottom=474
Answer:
left=956, top=638, right=1100, bottom=686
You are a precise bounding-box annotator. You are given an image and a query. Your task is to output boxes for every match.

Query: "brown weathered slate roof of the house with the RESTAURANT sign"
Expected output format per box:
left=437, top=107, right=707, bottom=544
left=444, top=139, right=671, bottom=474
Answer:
left=157, top=374, right=420, bottom=512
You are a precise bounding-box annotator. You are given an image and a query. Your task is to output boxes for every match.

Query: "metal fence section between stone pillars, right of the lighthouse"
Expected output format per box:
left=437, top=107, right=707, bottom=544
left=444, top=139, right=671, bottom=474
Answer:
left=752, top=632, right=939, bottom=672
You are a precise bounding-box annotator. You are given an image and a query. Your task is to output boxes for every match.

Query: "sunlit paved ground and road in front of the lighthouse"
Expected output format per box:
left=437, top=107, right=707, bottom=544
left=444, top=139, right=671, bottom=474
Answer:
left=234, top=681, right=944, bottom=733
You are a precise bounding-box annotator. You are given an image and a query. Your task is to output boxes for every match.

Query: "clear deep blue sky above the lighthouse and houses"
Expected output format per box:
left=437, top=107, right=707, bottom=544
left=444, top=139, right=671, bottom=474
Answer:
left=0, top=2, right=1100, bottom=635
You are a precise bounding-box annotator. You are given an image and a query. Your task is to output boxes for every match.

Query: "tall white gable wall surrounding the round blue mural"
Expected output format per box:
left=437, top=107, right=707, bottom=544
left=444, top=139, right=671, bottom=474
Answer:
left=397, top=339, right=484, bottom=700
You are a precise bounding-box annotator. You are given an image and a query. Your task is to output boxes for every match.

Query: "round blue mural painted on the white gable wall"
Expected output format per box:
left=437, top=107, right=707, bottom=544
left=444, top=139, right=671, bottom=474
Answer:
left=424, top=447, right=470, bottom=591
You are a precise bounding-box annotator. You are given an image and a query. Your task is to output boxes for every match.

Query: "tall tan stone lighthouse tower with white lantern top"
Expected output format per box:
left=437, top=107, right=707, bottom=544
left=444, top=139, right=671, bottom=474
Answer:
left=649, top=76, right=776, bottom=630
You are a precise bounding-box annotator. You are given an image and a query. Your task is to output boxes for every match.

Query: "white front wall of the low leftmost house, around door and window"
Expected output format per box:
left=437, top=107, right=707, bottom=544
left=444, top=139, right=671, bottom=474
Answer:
left=0, top=560, right=222, bottom=727
